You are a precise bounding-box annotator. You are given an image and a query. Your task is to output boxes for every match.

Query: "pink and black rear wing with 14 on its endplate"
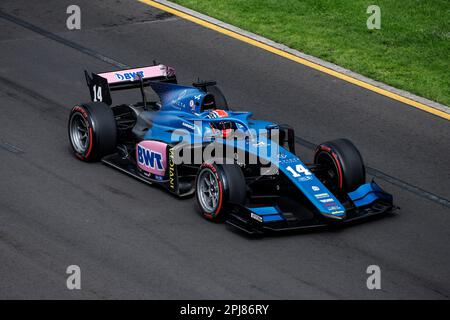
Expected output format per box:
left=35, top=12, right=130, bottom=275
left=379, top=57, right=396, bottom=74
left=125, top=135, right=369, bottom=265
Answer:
left=84, top=64, right=177, bottom=105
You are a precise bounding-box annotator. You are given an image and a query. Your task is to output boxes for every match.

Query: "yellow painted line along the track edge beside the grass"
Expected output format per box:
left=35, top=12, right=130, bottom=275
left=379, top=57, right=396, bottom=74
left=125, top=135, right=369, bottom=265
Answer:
left=138, top=0, right=450, bottom=120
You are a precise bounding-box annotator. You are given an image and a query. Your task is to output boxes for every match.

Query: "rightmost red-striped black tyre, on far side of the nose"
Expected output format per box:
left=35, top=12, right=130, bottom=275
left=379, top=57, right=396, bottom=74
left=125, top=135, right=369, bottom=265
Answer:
left=314, top=139, right=366, bottom=193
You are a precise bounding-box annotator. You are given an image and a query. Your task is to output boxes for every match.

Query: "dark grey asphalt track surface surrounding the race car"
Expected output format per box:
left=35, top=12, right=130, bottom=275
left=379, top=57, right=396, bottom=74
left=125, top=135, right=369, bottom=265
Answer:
left=0, top=0, right=450, bottom=299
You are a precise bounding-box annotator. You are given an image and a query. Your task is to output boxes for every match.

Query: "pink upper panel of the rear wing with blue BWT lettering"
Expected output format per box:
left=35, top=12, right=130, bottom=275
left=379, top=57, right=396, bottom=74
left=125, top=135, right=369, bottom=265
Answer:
left=98, top=64, right=175, bottom=84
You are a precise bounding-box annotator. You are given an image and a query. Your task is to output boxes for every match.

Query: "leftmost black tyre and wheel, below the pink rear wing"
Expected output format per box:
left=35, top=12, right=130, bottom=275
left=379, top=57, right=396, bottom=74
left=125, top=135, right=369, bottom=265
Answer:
left=68, top=102, right=117, bottom=161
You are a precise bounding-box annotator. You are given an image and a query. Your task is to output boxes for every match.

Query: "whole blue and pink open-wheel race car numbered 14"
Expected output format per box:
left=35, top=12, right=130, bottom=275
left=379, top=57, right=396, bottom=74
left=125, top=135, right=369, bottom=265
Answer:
left=68, top=64, right=396, bottom=234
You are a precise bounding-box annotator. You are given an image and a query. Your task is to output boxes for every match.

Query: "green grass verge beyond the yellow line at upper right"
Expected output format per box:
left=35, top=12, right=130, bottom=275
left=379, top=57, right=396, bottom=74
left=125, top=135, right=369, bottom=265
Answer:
left=172, top=0, right=450, bottom=106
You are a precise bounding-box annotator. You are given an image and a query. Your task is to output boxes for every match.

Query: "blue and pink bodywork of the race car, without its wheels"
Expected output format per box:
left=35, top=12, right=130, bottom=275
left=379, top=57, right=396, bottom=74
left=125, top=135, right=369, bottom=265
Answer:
left=80, top=65, right=395, bottom=233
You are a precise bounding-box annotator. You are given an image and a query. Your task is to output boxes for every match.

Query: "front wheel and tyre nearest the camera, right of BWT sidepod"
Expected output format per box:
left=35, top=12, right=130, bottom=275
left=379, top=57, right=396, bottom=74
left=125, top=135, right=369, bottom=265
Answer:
left=195, top=163, right=246, bottom=221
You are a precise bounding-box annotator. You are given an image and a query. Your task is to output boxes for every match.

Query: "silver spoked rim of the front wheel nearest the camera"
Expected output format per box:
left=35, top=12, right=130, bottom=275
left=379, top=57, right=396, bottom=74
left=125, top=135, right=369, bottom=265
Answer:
left=197, top=169, right=220, bottom=213
